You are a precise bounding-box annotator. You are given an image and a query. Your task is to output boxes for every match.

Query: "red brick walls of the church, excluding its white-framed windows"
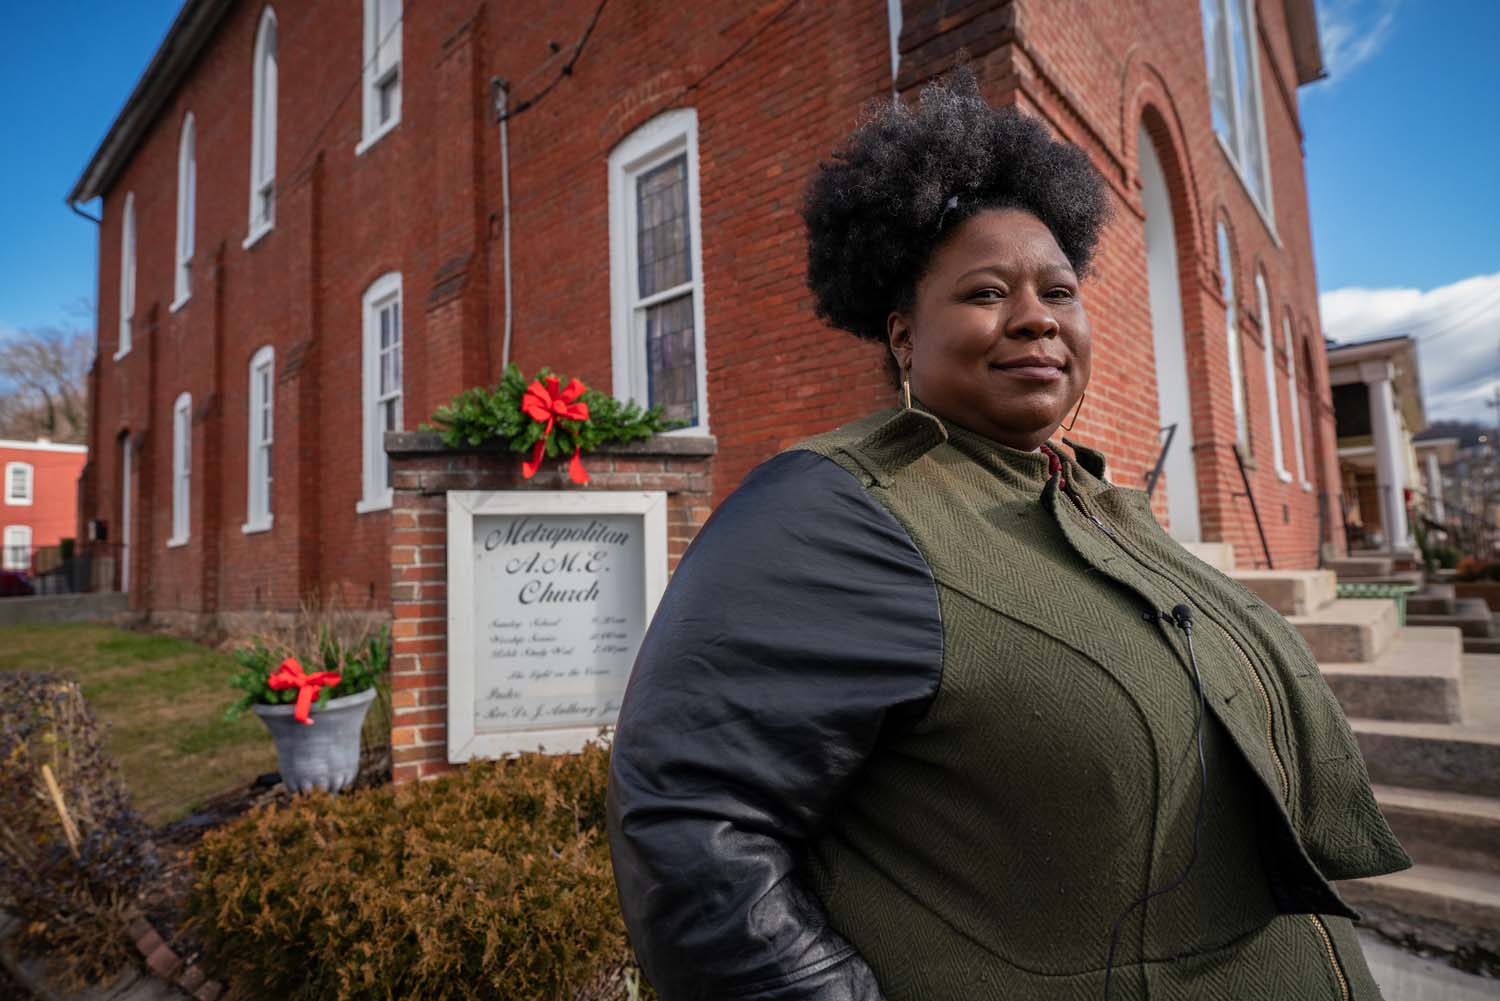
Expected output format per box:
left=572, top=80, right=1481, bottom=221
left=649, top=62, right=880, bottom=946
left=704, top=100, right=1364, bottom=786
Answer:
left=83, top=0, right=1343, bottom=627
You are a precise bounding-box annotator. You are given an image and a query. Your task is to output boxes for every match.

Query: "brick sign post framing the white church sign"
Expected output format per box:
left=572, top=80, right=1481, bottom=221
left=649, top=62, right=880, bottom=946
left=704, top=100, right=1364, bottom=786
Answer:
left=386, top=432, right=717, bottom=785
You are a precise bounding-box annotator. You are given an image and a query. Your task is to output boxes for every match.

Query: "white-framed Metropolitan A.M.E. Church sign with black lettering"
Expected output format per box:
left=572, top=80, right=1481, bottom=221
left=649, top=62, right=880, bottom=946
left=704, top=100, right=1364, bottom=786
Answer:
left=447, top=491, right=668, bottom=762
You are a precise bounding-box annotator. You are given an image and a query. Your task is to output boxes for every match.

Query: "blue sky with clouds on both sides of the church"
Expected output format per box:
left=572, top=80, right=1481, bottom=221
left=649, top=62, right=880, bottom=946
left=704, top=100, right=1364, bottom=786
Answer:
left=0, top=0, right=1500, bottom=419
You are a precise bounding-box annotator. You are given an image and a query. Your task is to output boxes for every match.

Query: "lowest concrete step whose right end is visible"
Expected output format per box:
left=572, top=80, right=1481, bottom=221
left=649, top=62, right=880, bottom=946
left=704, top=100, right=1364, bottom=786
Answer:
left=1319, top=626, right=1464, bottom=723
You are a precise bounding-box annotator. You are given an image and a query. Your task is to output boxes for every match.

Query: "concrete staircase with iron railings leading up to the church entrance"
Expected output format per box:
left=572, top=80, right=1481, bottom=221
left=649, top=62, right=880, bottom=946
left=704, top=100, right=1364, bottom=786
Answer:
left=1190, top=545, right=1500, bottom=956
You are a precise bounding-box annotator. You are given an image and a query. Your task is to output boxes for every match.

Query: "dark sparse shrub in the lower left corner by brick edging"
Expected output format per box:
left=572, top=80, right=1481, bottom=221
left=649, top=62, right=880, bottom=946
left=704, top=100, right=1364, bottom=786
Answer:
left=0, top=674, right=161, bottom=981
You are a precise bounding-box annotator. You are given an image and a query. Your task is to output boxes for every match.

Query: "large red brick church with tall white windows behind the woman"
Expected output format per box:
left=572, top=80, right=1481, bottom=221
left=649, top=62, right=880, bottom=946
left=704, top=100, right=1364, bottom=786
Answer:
left=71, top=0, right=1341, bottom=627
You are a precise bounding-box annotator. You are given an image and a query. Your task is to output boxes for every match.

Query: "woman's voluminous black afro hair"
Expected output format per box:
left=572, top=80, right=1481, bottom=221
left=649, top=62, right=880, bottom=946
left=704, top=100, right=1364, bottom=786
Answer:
left=803, top=68, right=1110, bottom=342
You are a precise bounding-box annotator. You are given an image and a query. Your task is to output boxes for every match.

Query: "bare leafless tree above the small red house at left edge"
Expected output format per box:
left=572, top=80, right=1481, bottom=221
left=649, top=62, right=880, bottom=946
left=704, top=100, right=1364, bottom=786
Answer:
left=0, top=324, right=93, bottom=443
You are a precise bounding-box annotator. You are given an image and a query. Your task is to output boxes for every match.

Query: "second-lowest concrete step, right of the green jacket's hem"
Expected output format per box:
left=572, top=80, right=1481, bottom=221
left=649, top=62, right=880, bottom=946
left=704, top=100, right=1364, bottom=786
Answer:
left=1374, top=785, right=1500, bottom=873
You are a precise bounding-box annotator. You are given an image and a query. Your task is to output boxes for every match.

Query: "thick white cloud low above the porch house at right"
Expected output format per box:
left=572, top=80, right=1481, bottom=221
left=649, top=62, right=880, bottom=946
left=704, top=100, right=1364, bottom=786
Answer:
left=1319, top=273, right=1500, bottom=425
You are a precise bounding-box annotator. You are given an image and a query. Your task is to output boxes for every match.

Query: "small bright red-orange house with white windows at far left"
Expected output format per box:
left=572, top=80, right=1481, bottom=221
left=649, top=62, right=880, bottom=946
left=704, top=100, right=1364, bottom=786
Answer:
left=0, top=438, right=89, bottom=573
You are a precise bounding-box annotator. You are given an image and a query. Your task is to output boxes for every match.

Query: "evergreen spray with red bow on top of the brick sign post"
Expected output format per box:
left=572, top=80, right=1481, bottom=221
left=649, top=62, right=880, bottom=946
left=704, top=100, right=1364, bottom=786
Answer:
left=432, top=363, right=683, bottom=482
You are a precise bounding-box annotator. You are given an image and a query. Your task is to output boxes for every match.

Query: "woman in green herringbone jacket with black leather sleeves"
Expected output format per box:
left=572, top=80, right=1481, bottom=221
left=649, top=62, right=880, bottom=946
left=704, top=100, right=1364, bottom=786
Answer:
left=609, top=74, right=1410, bottom=1001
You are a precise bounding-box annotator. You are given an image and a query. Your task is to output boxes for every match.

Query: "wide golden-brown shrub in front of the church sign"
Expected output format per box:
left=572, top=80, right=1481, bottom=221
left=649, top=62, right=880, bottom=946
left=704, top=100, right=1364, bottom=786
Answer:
left=188, top=744, right=651, bottom=1001
